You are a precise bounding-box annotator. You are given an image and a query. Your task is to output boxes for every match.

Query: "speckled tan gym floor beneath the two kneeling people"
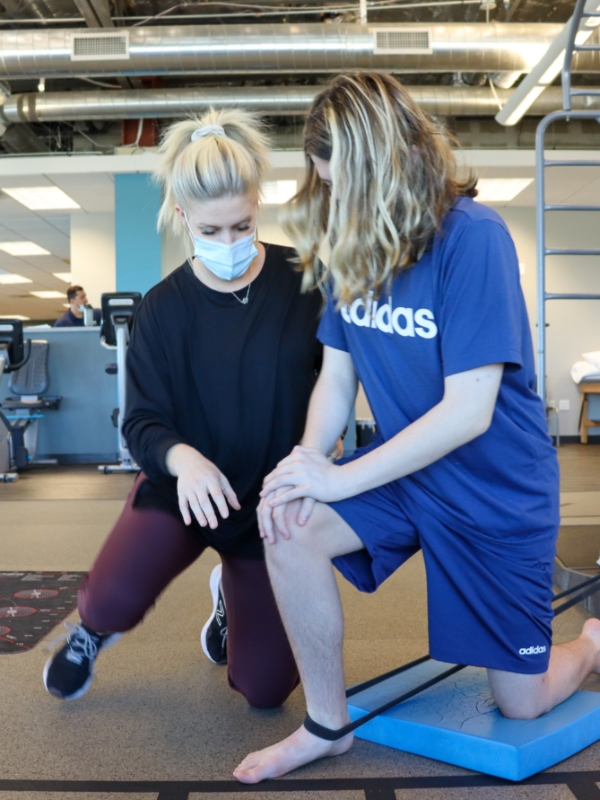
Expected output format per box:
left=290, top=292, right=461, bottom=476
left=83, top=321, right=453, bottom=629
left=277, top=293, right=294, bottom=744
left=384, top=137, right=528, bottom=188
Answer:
left=0, top=445, right=600, bottom=800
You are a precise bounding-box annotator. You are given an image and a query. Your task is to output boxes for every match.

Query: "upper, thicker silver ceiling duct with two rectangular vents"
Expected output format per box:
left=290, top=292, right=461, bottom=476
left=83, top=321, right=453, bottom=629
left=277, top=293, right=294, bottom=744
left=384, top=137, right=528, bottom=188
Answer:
left=0, top=22, right=600, bottom=79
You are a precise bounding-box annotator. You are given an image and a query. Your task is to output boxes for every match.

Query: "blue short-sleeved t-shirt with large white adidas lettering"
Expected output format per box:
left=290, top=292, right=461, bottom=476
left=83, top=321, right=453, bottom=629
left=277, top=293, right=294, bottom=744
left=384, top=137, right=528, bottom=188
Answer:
left=319, top=197, right=559, bottom=543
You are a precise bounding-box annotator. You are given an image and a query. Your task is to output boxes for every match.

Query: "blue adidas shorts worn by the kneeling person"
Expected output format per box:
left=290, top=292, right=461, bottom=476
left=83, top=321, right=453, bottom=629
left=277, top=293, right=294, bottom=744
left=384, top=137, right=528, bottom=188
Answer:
left=329, top=447, right=557, bottom=674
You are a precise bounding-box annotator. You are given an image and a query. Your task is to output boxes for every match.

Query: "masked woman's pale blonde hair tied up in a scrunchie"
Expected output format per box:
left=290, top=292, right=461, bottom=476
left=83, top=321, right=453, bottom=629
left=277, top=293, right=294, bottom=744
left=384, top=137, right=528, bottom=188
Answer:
left=154, top=109, right=270, bottom=240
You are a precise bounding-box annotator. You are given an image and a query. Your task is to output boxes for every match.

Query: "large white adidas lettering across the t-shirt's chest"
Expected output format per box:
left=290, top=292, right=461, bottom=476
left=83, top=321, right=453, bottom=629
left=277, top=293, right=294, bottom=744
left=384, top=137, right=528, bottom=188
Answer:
left=341, top=298, right=438, bottom=339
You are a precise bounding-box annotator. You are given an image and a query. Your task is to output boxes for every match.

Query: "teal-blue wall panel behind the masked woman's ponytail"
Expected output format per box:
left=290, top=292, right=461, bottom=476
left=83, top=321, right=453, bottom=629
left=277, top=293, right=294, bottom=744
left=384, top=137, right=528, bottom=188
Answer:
left=115, top=173, right=161, bottom=294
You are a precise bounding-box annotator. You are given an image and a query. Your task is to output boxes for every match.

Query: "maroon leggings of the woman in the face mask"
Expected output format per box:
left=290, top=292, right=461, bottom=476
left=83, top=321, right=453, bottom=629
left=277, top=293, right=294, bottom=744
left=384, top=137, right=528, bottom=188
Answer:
left=79, top=482, right=299, bottom=708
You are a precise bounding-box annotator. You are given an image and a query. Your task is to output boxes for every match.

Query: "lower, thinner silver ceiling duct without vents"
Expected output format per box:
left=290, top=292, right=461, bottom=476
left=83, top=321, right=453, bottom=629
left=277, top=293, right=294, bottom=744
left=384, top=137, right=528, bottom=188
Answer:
left=0, top=86, right=600, bottom=124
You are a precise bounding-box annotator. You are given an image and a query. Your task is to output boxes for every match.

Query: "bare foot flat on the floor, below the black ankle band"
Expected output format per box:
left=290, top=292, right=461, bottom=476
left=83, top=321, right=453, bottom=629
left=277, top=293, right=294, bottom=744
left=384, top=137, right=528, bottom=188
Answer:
left=233, top=726, right=354, bottom=783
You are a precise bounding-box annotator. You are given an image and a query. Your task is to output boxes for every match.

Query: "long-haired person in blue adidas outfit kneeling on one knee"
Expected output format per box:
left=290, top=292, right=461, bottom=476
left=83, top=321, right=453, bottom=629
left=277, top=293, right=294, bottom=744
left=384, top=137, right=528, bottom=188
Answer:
left=234, top=73, right=600, bottom=783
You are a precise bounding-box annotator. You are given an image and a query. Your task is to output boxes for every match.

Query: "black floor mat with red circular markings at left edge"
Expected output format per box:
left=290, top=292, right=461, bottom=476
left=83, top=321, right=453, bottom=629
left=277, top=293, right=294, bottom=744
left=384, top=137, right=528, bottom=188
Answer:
left=0, top=572, right=85, bottom=655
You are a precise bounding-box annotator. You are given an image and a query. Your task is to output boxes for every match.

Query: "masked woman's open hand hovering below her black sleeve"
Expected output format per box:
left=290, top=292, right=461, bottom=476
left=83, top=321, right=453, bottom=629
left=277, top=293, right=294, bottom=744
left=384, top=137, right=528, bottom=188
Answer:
left=165, top=444, right=241, bottom=530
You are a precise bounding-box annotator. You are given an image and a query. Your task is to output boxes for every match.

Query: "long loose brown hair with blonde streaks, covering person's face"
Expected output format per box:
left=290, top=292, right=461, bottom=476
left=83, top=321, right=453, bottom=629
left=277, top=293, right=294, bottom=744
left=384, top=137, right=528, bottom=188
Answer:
left=282, top=72, right=477, bottom=303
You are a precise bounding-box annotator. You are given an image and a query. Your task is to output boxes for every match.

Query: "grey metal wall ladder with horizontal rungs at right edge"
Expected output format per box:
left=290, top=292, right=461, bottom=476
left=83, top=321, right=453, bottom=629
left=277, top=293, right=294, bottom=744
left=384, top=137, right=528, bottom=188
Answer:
left=535, top=0, right=600, bottom=407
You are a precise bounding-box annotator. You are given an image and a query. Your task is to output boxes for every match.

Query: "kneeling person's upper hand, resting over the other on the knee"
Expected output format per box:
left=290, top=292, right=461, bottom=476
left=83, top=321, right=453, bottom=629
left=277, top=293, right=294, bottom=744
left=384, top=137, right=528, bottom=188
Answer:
left=261, top=446, right=348, bottom=510
